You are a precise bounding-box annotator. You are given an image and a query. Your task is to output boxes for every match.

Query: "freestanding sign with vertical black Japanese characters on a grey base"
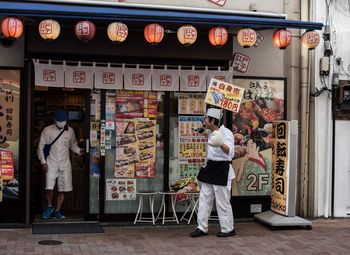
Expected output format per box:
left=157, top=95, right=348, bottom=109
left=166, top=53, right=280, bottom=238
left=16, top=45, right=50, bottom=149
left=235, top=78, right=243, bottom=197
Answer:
left=254, top=120, right=312, bottom=230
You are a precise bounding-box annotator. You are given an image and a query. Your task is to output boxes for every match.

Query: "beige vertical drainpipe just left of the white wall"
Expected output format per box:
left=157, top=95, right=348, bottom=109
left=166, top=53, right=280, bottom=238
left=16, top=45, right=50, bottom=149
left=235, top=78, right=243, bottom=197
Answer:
left=299, top=0, right=310, bottom=217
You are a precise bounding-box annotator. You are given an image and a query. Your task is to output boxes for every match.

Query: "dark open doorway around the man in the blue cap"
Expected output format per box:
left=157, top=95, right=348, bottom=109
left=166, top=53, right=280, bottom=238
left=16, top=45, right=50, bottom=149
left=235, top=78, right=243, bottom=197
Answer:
left=31, top=87, right=90, bottom=221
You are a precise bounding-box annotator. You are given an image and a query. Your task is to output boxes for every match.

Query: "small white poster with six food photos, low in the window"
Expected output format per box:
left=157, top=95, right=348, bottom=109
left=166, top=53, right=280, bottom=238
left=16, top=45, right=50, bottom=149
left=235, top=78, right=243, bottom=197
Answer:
left=106, top=179, right=136, bottom=201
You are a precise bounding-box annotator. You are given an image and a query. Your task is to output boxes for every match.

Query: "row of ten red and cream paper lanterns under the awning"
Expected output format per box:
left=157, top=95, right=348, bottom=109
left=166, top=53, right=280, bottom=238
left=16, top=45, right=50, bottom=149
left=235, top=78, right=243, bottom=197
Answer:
left=1, top=17, right=320, bottom=49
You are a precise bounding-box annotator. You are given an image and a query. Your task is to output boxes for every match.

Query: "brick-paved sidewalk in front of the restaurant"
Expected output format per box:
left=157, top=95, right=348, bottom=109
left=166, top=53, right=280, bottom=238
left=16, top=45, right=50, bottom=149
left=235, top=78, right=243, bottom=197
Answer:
left=0, top=219, right=350, bottom=255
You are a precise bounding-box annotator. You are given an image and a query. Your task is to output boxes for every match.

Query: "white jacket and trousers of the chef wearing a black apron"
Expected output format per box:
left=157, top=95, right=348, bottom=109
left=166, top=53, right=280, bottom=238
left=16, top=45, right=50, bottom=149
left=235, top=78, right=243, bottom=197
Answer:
left=197, top=125, right=235, bottom=233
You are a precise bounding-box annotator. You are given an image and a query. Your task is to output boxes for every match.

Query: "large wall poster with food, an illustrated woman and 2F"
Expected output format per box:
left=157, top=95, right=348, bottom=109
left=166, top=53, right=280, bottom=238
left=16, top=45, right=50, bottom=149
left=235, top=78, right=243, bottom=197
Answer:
left=231, top=78, right=285, bottom=196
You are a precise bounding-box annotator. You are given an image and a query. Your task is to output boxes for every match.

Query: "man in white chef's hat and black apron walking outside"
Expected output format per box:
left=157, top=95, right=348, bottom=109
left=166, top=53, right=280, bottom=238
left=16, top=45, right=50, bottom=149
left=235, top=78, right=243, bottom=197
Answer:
left=191, top=108, right=236, bottom=237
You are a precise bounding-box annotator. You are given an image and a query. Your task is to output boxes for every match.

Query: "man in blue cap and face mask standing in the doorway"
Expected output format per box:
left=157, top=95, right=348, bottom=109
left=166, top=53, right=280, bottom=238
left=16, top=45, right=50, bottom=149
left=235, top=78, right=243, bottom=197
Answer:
left=37, top=110, right=83, bottom=220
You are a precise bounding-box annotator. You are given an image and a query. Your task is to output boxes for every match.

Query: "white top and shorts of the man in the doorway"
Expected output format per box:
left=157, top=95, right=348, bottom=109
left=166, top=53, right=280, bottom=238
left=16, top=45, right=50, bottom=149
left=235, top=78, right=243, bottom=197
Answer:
left=37, top=124, right=80, bottom=192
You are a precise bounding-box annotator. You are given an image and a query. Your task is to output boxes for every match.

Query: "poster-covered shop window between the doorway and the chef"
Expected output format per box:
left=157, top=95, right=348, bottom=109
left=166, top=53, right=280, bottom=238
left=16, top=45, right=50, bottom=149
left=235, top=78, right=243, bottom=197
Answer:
left=100, top=90, right=165, bottom=214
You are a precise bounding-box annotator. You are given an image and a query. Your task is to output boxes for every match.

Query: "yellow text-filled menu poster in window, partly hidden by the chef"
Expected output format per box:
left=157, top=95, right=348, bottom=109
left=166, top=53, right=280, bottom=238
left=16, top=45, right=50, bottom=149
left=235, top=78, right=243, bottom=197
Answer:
left=178, top=116, right=206, bottom=178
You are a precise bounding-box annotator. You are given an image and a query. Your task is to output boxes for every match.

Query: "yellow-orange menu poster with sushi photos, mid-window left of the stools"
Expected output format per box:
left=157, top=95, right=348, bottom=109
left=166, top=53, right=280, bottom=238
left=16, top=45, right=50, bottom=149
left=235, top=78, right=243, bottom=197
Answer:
left=114, top=119, right=156, bottom=178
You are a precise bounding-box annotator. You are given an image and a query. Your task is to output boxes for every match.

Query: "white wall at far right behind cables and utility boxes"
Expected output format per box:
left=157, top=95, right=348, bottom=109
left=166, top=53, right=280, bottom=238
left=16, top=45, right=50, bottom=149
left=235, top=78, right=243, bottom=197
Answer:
left=311, top=0, right=350, bottom=217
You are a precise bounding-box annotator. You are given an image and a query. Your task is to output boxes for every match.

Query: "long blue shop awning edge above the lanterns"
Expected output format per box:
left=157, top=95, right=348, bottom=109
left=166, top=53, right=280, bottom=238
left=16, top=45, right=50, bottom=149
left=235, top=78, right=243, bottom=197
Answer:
left=0, top=1, right=323, bottom=30
